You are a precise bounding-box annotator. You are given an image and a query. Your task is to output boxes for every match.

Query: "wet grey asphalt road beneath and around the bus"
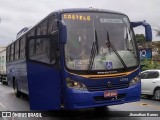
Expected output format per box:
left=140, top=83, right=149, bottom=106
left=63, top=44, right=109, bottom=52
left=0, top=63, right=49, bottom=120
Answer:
left=0, top=83, right=160, bottom=120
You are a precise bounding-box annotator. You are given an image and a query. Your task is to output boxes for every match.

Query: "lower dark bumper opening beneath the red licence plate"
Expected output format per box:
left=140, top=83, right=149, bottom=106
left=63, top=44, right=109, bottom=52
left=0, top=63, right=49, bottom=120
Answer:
left=93, top=93, right=126, bottom=101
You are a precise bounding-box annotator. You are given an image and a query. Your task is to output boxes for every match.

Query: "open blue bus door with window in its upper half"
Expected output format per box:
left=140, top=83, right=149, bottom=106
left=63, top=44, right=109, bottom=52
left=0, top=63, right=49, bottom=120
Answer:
left=27, top=35, right=61, bottom=110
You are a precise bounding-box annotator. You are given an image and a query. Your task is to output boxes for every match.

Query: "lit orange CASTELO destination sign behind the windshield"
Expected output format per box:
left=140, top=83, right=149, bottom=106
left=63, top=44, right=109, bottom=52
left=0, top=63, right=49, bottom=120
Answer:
left=63, top=14, right=91, bottom=21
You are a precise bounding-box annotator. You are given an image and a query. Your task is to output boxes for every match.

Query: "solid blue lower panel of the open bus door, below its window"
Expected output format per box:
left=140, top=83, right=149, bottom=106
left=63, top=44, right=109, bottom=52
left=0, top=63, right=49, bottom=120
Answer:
left=27, top=61, right=61, bottom=110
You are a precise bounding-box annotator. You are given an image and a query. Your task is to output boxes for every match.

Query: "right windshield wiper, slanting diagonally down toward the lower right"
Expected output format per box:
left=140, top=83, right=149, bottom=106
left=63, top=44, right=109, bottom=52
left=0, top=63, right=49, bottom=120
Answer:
left=106, top=32, right=127, bottom=69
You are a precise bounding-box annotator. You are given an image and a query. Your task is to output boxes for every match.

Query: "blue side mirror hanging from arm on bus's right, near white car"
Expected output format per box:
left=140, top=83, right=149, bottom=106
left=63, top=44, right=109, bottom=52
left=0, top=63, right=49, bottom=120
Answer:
left=144, top=25, right=152, bottom=41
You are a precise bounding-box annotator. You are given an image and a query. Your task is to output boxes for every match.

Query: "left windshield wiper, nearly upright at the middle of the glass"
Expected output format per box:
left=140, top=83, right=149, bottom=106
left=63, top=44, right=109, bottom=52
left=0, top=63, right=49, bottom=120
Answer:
left=87, top=30, right=98, bottom=72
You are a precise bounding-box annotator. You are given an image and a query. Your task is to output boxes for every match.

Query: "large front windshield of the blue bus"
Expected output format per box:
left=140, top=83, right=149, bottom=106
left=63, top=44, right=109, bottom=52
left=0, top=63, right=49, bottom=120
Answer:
left=62, top=12, right=138, bottom=70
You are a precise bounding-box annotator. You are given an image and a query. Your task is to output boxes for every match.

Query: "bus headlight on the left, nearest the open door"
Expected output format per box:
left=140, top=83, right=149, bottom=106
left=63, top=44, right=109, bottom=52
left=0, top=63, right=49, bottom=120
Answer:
left=66, top=78, right=87, bottom=90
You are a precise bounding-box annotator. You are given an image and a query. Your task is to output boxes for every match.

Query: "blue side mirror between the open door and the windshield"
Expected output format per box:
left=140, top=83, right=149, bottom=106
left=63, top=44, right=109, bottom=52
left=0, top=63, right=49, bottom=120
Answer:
left=57, top=20, right=67, bottom=44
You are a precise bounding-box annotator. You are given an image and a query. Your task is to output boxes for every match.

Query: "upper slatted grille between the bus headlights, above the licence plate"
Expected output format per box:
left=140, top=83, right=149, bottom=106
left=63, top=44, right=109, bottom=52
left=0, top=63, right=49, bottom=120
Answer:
left=87, top=83, right=128, bottom=92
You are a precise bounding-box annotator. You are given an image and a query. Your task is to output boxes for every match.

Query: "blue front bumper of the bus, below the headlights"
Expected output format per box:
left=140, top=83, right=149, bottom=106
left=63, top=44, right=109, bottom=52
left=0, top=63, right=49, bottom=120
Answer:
left=64, top=82, right=141, bottom=109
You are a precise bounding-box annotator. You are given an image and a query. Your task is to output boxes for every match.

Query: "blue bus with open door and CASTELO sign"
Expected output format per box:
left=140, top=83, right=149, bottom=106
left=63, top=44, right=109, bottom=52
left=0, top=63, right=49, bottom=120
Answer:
left=6, top=8, right=151, bottom=110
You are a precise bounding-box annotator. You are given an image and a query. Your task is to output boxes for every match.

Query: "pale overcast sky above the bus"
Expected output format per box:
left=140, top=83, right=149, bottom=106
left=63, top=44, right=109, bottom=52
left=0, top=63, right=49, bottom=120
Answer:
left=0, top=0, right=160, bottom=46
